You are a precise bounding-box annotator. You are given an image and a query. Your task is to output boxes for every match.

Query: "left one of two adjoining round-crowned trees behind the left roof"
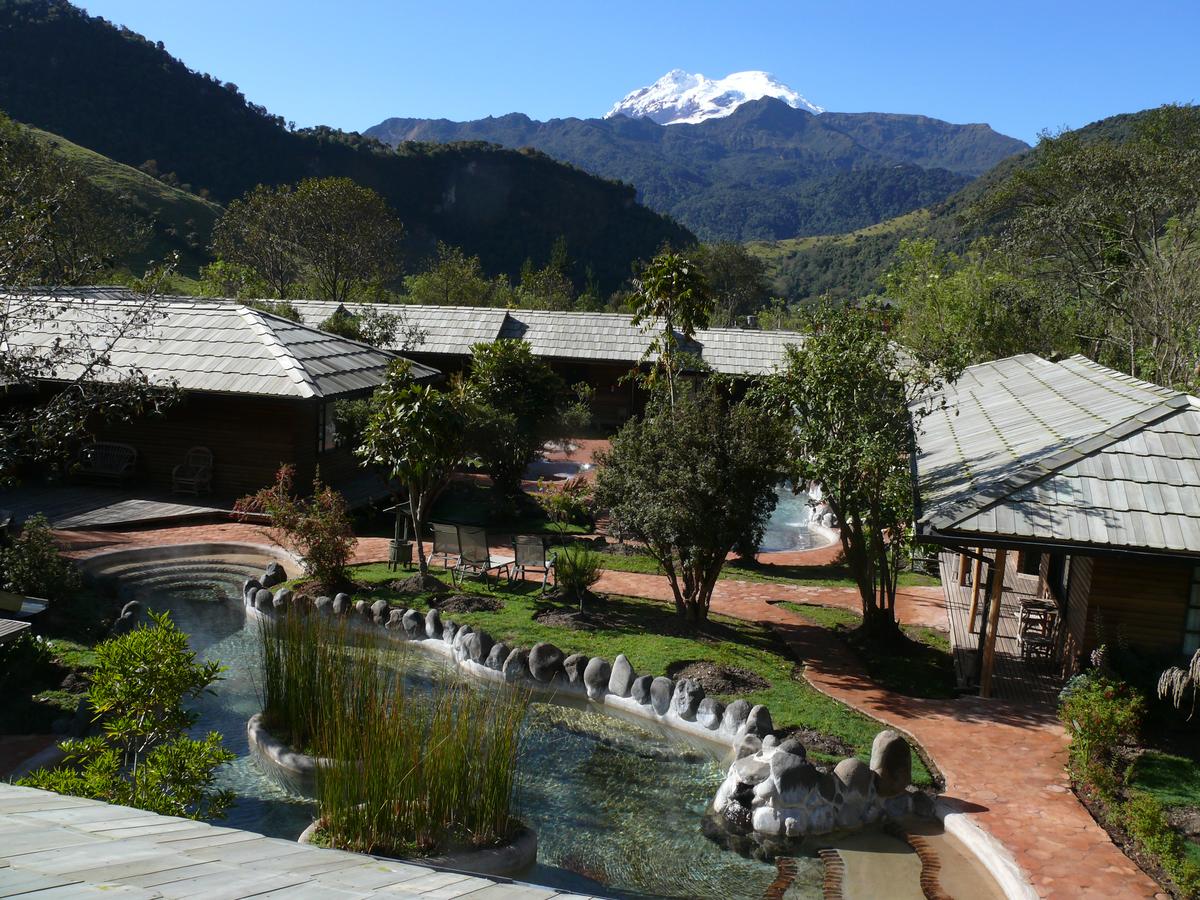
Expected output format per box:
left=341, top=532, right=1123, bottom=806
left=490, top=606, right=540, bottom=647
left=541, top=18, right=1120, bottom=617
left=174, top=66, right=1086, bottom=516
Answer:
left=204, top=185, right=304, bottom=300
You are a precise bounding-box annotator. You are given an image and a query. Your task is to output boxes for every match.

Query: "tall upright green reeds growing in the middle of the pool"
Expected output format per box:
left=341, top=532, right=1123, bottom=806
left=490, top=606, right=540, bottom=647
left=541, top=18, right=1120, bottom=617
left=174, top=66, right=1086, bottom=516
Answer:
left=263, top=614, right=528, bottom=857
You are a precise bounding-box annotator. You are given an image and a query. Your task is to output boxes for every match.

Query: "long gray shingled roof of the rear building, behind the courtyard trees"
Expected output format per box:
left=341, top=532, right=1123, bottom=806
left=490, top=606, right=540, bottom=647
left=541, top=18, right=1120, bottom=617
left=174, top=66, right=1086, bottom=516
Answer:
left=286, top=301, right=802, bottom=374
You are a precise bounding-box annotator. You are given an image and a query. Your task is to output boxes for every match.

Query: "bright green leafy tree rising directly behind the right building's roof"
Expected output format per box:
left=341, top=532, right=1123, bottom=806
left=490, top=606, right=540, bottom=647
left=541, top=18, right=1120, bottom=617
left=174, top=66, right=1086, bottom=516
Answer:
left=884, top=239, right=1074, bottom=365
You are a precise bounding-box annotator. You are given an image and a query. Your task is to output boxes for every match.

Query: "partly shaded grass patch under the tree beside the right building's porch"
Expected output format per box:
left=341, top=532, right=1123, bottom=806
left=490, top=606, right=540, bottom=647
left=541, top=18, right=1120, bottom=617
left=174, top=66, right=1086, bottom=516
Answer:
left=779, top=602, right=958, bottom=698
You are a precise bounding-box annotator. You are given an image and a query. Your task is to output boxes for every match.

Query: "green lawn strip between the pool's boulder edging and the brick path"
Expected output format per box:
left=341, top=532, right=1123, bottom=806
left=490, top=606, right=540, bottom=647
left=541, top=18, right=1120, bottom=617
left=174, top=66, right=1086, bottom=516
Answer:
left=309, top=563, right=931, bottom=785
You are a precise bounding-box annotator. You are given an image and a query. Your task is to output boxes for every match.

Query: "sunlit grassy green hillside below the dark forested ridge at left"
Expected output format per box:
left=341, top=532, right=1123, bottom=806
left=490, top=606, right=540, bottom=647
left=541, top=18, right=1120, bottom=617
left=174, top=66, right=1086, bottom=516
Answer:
left=26, top=126, right=221, bottom=277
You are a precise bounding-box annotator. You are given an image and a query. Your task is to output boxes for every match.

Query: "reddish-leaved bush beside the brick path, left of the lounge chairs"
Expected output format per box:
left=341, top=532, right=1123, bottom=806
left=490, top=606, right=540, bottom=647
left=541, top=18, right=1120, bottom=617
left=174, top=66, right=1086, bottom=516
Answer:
left=234, top=466, right=358, bottom=592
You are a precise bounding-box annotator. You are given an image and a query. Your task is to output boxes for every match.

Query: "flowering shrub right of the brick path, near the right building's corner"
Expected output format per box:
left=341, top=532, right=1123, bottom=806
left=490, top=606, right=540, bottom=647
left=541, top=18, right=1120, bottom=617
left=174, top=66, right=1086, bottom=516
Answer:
left=1058, top=676, right=1146, bottom=772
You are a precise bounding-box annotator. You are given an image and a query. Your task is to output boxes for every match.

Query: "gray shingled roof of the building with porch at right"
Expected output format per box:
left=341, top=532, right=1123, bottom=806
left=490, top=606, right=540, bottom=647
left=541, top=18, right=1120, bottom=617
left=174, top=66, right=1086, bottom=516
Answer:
left=916, top=354, right=1200, bottom=553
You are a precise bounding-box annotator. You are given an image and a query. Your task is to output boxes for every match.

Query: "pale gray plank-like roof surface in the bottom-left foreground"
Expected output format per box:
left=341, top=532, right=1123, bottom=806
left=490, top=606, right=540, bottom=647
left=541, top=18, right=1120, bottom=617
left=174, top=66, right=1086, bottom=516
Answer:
left=0, top=784, right=587, bottom=900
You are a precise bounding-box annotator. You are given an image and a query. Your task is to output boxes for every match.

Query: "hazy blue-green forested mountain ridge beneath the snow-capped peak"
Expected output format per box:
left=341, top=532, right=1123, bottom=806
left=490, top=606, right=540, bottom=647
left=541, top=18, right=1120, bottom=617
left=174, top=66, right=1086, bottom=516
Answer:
left=366, top=98, right=1027, bottom=240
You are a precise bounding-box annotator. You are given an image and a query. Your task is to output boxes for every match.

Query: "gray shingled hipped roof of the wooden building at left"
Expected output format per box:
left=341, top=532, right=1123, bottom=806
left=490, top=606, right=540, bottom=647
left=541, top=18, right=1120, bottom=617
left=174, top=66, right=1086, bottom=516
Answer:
left=3, top=290, right=437, bottom=398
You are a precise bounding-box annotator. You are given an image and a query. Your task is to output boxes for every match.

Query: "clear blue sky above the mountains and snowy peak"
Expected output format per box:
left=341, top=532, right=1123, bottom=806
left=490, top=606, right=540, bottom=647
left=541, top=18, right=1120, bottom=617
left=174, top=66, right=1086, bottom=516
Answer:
left=83, top=0, right=1200, bottom=142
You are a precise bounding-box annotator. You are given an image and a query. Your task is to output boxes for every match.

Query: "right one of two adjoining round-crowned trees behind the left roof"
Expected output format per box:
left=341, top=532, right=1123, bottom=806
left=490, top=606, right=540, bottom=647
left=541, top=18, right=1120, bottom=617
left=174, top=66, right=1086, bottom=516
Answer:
left=289, top=178, right=404, bottom=302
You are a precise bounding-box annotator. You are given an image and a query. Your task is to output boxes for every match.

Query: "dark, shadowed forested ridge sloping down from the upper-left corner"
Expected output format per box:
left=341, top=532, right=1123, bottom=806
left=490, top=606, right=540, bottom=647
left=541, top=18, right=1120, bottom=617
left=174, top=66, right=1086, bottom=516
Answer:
left=0, top=0, right=694, bottom=289
